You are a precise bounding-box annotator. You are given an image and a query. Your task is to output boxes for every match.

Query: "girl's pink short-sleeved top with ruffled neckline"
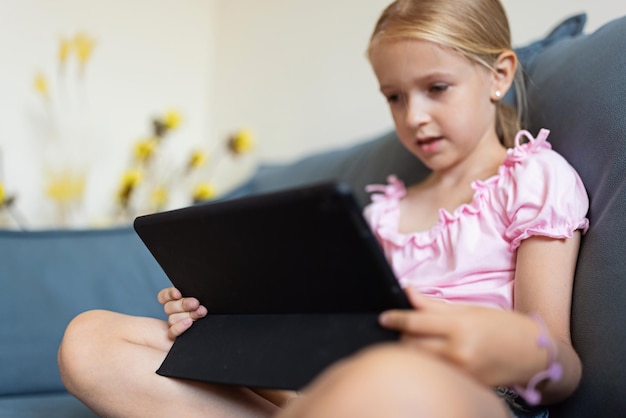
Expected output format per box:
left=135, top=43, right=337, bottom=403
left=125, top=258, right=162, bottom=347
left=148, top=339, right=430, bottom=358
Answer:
left=365, top=129, right=589, bottom=309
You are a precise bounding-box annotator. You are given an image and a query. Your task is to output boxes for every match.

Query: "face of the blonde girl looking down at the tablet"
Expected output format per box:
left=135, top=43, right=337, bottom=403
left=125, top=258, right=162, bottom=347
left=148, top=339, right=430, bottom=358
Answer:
left=370, top=39, right=502, bottom=172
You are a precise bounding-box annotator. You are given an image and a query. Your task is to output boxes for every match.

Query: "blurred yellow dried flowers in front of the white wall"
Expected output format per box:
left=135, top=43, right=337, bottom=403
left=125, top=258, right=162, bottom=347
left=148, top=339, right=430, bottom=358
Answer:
left=0, top=33, right=253, bottom=229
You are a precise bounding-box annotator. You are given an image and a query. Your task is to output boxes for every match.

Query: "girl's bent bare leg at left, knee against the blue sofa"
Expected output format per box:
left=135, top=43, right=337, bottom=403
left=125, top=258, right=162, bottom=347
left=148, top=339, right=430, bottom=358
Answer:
left=59, top=311, right=278, bottom=417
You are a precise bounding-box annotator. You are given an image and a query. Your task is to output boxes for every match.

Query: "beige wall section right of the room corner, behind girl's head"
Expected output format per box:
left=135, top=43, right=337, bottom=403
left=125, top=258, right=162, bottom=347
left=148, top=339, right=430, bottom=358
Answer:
left=213, top=0, right=626, bottom=161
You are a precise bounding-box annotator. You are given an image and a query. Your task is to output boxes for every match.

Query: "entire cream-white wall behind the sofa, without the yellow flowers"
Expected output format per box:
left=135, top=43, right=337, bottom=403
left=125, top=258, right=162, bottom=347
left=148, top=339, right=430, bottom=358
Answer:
left=0, top=0, right=626, bottom=227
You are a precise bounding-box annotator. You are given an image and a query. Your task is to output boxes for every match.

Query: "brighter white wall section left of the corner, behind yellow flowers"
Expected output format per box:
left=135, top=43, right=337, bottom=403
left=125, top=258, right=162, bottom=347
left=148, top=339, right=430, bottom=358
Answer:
left=0, top=0, right=215, bottom=227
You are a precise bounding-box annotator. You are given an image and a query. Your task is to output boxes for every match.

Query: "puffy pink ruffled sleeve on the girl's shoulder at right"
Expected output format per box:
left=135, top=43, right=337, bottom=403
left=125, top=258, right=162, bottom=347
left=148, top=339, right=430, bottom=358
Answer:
left=499, top=129, right=589, bottom=250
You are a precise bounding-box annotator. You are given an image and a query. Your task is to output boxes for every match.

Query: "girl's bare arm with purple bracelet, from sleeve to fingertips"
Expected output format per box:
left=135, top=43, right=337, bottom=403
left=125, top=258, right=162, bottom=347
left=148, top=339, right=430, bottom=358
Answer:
left=380, top=232, right=581, bottom=403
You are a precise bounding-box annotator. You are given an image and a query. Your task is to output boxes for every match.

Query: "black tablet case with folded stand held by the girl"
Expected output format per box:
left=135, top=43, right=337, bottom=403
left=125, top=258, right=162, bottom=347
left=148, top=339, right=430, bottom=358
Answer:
left=134, top=183, right=410, bottom=389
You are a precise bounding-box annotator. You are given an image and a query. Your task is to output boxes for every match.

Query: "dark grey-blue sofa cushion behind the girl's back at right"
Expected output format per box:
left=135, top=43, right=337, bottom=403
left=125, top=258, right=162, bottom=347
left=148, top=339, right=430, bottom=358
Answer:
left=528, top=17, right=626, bottom=417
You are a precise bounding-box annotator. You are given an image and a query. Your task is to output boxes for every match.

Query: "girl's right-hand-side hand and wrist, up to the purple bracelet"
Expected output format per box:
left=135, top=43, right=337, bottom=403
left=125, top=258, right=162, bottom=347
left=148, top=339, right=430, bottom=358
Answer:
left=380, top=290, right=549, bottom=386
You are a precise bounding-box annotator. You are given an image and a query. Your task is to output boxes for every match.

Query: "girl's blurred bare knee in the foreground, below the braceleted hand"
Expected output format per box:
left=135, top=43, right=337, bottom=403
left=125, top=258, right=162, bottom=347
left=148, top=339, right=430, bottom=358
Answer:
left=278, top=345, right=509, bottom=418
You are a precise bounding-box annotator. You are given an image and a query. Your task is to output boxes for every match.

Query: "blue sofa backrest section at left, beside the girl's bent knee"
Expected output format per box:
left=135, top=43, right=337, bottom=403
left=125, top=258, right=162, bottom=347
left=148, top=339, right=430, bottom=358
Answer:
left=0, top=228, right=169, bottom=395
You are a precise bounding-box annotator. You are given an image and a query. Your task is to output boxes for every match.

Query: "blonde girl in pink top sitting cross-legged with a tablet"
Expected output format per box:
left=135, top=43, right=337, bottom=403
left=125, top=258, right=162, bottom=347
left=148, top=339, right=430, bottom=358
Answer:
left=59, top=0, right=588, bottom=418
